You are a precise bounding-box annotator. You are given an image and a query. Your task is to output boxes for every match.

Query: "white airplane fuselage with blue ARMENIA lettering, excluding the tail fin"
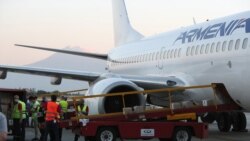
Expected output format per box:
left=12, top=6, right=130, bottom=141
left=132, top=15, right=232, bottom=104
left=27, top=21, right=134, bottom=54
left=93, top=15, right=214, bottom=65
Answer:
left=108, top=12, right=250, bottom=111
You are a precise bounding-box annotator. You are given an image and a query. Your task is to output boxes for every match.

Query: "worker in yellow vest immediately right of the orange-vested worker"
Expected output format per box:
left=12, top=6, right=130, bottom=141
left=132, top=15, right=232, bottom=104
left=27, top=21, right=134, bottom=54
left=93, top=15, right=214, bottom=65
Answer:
left=59, top=96, right=69, bottom=141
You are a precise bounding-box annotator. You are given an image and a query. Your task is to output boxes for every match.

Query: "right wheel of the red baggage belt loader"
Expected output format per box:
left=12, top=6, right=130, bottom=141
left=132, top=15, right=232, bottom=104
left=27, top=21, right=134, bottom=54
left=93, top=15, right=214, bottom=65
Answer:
left=172, top=127, right=192, bottom=141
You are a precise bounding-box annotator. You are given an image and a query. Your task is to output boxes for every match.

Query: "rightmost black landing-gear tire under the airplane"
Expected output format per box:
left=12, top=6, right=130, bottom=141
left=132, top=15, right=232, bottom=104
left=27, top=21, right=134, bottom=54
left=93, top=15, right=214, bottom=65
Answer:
left=232, top=112, right=247, bottom=132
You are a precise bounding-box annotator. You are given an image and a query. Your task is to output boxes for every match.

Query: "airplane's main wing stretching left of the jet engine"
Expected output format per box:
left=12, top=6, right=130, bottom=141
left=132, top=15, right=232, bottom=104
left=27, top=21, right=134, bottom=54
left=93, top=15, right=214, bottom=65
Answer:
left=0, top=65, right=101, bottom=84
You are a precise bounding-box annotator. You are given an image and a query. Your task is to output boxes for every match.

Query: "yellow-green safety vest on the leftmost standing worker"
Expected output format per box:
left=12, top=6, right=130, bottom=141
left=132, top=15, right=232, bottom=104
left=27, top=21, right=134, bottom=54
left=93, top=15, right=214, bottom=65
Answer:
left=11, top=100, right=26, bottom=119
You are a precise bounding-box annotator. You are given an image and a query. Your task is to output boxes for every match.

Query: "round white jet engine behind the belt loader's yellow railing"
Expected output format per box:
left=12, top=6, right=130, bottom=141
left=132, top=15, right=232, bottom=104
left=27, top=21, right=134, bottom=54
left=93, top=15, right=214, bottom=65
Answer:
left=86, top=78, right=146, bottom=114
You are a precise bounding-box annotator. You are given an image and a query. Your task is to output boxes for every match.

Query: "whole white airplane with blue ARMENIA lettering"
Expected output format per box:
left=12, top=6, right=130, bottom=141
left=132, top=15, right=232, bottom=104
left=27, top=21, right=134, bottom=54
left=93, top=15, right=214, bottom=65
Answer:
left=0, top=0, right=250, bottom=132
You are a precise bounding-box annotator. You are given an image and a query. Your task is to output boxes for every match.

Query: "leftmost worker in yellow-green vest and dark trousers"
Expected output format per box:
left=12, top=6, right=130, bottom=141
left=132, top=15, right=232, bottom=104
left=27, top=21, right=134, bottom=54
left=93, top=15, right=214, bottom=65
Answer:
left=11, top=95, right=26, bottom=141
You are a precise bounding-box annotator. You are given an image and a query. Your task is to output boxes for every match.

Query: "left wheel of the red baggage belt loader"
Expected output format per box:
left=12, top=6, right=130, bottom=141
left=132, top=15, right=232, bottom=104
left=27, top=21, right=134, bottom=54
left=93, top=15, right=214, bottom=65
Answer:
left=96, top=127, right=117, bottom=141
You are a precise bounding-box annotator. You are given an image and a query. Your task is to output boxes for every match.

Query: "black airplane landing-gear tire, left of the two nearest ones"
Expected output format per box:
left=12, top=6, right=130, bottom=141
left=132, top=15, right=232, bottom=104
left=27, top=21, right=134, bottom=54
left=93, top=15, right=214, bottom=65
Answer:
left=217, top=112, right=232, bottom=132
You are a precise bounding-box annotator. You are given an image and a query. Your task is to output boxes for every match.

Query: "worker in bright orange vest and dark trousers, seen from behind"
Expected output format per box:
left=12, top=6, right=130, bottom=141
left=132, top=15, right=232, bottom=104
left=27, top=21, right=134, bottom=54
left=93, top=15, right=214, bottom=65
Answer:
left=43, top=95, right=61, bottom=141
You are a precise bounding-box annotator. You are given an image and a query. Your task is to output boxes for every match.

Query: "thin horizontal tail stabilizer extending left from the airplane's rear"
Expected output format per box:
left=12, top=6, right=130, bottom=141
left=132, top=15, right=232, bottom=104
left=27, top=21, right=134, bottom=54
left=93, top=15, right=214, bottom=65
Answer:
left=15, top=44, right=108, bottom=60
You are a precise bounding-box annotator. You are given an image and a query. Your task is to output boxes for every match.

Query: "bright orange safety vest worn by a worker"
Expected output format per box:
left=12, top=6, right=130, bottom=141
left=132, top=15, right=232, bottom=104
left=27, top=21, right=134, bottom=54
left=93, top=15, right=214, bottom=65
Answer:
left=45, top=102, right=59, bottom=121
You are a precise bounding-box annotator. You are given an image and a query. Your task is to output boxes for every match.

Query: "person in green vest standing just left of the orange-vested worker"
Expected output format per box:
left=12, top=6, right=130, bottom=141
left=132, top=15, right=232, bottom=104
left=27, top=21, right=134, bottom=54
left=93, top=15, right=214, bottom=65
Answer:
left=30, top=96, right=40, bottom=141
